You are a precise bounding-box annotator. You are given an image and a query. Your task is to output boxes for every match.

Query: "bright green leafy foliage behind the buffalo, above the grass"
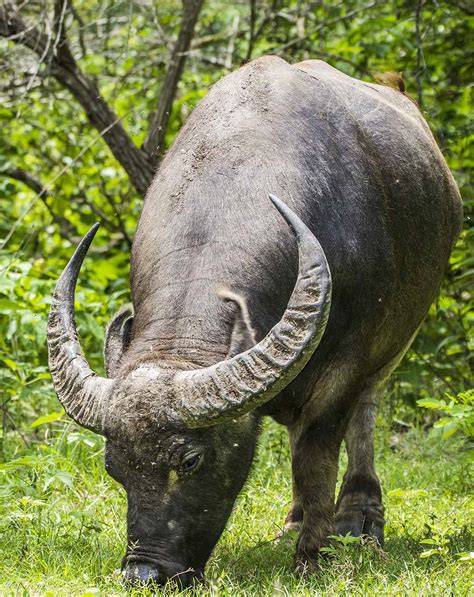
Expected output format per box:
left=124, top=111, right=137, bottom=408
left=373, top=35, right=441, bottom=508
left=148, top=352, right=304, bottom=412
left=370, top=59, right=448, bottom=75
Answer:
left=0, top=0, right=474, bottom=429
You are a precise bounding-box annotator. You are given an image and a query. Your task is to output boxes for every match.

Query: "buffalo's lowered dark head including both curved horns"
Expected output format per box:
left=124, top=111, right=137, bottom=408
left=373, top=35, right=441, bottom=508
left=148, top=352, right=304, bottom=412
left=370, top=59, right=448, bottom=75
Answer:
left=48, top=196, right=331, bottom=586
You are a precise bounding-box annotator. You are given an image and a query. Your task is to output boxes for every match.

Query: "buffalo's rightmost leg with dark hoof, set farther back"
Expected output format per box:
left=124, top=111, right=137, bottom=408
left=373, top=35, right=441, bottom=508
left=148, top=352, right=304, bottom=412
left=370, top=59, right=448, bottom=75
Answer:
left=335, top=392, right=384, bottom=546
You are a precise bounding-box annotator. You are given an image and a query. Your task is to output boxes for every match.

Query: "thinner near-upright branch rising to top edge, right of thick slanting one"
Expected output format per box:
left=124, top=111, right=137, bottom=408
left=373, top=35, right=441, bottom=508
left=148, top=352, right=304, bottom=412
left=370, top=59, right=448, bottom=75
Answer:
left=142, top=0, right=204, bottom=167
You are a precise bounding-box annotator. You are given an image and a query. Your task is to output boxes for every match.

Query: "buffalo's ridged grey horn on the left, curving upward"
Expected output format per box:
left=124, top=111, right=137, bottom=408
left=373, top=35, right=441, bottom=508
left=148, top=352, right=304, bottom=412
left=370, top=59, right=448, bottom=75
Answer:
left=48, top=224, right=113, bottom=433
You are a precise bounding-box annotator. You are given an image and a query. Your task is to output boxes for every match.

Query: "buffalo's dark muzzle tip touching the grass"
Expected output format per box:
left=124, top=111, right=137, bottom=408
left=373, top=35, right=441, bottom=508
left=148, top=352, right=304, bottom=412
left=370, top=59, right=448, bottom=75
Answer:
left=122, top=554, right=204, bottom=589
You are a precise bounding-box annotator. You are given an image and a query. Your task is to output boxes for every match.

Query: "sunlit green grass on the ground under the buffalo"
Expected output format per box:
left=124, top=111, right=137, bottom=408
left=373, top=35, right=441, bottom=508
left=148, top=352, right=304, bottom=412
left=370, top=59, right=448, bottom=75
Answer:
left=0, top=416, right=474, bottom=596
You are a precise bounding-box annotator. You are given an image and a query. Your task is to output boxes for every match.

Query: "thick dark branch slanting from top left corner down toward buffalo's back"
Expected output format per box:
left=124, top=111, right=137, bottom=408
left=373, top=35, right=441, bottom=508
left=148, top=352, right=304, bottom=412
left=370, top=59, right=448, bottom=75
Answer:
left=0, top=0, right=153, bottom=195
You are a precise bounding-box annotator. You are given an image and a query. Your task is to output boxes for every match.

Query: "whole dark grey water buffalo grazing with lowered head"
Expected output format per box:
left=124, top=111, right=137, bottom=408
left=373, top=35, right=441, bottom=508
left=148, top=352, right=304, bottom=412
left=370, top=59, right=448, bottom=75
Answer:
left=48, top=57, right=461, bottom=586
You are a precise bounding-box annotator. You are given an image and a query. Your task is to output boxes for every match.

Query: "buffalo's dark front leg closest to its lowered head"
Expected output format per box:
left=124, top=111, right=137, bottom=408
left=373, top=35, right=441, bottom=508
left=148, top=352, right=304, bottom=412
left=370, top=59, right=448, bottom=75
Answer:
left=288, top=421, right=342, bottom=572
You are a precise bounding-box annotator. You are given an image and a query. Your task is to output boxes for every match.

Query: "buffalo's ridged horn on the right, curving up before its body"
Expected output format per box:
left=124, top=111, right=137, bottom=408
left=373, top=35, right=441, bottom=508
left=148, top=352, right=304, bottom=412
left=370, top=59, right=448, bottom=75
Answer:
left=174, top=195, right=331, bottom=427
